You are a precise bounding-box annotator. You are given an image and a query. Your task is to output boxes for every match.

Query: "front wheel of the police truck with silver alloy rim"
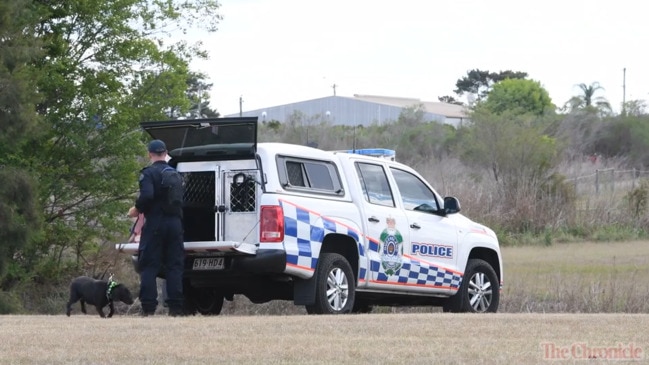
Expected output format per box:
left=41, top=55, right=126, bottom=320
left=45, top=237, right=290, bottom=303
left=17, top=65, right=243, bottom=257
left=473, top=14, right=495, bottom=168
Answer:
left=443, top=259, right=500, bottom=313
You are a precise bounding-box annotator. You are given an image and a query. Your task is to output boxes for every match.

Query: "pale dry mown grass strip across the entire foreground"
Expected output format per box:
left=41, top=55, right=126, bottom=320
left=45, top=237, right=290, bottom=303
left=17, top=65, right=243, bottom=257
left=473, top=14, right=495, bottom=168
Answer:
left=0, top=313, right=649, bottom=364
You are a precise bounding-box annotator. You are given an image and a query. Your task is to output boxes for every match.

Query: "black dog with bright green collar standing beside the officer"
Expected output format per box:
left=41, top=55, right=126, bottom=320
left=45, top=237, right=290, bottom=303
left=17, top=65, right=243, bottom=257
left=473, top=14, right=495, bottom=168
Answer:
left=65, top=276, right=133, bottom=318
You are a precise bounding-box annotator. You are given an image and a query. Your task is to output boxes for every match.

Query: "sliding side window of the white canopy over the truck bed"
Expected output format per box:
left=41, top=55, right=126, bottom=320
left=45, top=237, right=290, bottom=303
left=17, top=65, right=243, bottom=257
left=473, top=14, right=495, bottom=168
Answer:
left=277, top=156, right=343, bottom=195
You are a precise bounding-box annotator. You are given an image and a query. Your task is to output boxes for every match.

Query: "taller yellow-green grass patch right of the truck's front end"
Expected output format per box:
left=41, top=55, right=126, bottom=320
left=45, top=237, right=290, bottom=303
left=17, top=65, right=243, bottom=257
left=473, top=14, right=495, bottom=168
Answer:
left=500, top=241, right=649, bottom=313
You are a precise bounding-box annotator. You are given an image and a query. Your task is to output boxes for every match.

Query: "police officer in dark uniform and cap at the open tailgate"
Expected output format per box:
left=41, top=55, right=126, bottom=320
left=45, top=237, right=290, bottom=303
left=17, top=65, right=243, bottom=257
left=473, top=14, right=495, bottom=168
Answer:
left=129, top=139, right=185, bottom=316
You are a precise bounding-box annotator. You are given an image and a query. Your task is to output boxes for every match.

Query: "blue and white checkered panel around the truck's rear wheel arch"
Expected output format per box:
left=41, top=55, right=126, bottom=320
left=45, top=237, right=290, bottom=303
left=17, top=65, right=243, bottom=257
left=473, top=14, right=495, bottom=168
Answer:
left=279, top=200, right=367, bottom=278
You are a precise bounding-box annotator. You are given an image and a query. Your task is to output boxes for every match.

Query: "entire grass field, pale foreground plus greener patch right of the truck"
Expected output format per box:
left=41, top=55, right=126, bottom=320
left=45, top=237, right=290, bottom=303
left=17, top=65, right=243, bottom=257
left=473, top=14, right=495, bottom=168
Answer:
left=0, top=241, right=649, bottom=364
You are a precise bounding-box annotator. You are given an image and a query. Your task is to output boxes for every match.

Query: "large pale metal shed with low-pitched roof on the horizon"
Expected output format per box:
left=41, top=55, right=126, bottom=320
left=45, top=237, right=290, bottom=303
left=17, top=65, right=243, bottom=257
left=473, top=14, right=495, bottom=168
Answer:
left=226, top=94, right=467, bottom=127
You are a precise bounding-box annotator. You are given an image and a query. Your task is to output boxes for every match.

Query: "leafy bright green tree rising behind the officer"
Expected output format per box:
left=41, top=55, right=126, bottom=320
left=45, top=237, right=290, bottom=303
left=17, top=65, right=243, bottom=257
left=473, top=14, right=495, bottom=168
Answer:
left=4, top=0, right=220, bottom=288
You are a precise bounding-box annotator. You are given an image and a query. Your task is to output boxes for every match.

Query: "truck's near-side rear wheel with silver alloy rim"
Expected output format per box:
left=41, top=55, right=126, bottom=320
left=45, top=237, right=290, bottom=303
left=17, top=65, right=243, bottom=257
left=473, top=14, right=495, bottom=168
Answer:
left=306, top=253, right=356, bottom=314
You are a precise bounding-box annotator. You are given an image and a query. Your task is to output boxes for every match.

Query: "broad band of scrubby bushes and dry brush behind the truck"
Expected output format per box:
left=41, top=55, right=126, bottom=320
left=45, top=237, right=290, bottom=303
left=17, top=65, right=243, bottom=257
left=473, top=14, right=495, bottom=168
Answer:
left=260, top=94, right=649, bottom=245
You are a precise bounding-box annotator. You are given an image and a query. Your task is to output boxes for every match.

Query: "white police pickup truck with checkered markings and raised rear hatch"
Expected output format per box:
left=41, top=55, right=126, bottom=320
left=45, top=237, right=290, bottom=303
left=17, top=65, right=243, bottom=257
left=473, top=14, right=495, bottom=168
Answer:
left=116, top=118, right=503, bottom=315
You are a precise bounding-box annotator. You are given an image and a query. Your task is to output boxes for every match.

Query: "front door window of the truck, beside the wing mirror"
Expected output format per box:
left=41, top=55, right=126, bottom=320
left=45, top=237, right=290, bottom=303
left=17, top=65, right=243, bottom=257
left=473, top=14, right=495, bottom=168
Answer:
left=390, top=168, right=439, bottom=212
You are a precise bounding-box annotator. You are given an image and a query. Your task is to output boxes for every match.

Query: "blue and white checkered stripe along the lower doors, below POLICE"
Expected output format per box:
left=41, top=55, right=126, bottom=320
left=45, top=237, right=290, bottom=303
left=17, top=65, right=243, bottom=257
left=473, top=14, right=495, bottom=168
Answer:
left=370, top=255, right=462, bottom=289
